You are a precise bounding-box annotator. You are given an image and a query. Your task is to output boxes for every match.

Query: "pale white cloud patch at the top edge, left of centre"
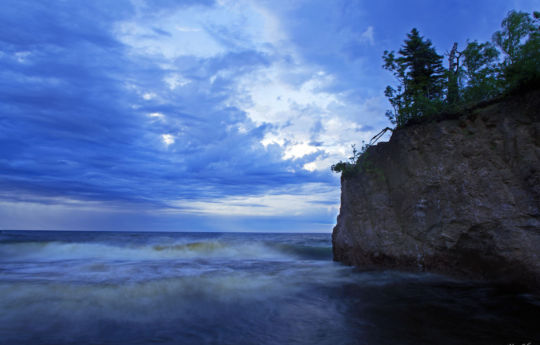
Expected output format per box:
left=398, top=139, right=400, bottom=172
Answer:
left=115, top=0, right=286, bottom=59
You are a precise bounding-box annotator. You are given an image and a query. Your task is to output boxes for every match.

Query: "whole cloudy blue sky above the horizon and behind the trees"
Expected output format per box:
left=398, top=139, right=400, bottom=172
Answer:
left=0, top=0, right=540, bottom=232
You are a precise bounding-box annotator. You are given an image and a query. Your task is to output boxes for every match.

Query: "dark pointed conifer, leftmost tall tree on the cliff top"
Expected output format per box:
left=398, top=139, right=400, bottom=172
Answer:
left=383, top=29, right=446, bottom=127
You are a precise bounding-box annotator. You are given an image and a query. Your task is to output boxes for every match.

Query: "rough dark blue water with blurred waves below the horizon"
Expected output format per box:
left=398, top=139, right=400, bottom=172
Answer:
left=0, top=231, right=540, bottom=345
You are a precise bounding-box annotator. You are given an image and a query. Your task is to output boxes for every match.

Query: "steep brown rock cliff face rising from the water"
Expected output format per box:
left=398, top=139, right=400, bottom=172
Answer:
left=332, top=90, right=540, bottom=288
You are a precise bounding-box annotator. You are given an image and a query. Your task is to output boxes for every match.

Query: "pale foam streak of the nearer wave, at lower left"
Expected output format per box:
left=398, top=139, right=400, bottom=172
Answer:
left=0, top=272, right=312, bottom=324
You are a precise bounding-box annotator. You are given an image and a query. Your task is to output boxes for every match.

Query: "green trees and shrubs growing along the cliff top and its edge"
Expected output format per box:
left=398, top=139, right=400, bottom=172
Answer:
left=331, top=11, right=540, bottom=177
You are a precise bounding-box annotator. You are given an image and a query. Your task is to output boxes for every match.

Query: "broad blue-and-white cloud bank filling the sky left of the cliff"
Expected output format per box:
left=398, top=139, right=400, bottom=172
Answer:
left=0, top=1, right=394, bottom=231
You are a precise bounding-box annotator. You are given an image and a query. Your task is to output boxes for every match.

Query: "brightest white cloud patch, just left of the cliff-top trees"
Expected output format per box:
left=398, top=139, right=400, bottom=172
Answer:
left=229, top=57, right=382, bottom=171
